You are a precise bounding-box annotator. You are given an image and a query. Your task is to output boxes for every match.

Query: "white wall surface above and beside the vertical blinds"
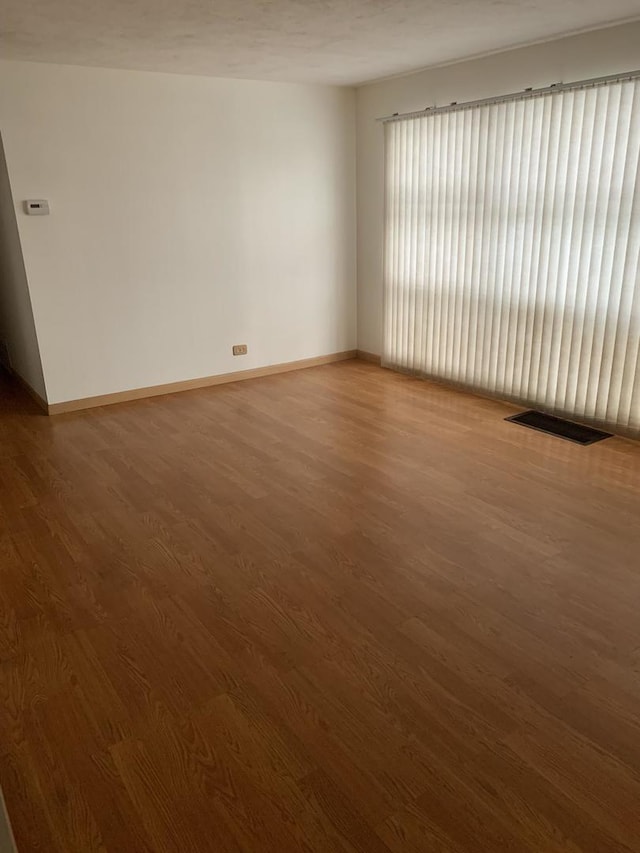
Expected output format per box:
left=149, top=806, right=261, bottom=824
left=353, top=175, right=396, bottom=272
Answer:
left=357, top=23, right=640, bottom=354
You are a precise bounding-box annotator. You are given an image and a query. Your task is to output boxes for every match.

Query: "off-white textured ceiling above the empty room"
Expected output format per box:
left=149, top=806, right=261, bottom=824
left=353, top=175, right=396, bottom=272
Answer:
left=0, top=0, right=640, bottom=85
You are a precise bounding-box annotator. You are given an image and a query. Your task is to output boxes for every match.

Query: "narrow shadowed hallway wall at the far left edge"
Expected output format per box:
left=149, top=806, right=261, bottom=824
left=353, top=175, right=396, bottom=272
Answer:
left=0, top=136, right=46, bottom=400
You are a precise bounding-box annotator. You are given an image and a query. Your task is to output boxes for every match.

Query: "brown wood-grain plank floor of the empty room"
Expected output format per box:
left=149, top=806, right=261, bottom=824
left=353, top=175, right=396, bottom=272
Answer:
left=0, top=362, right=640, bottom=853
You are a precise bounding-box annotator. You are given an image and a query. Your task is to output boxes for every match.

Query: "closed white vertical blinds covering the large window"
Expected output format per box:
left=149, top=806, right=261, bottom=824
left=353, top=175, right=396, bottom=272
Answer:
left=383, top=77, right=640, bottom=435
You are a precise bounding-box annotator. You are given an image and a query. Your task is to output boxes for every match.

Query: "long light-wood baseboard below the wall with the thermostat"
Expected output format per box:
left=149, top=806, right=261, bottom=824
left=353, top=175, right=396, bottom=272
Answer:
left=47, top=350, right=357, bottom=415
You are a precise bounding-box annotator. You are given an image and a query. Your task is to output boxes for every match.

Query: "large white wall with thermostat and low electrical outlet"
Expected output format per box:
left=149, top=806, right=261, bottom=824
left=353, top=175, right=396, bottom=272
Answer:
left=0, top=62, right=356, bottom=403
